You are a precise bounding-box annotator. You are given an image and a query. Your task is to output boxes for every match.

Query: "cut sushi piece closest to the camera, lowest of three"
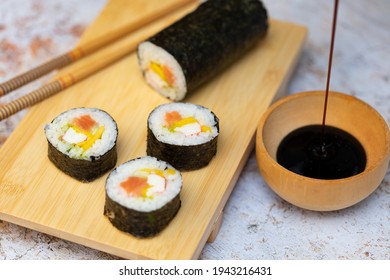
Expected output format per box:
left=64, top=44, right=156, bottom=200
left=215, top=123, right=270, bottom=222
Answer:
left=104, top=156, right=182, bottom=238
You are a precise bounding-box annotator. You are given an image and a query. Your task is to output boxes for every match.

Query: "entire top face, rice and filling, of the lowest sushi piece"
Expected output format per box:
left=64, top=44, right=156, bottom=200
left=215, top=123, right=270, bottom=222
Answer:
left=106, top=156, right=182, bottom=212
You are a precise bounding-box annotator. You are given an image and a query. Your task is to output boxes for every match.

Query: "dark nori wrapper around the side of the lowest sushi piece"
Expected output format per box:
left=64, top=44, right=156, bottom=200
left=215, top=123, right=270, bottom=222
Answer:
left=104, top=193, right=181, bottom=238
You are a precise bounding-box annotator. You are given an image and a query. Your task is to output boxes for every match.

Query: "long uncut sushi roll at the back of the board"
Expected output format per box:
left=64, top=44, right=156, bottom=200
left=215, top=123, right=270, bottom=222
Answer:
left=137, top=0, right=268, bottom=101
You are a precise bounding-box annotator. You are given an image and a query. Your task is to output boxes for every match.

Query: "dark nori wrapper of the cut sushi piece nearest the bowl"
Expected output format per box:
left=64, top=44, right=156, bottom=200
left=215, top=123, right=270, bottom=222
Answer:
left=146, top=113, right=219, bottom=171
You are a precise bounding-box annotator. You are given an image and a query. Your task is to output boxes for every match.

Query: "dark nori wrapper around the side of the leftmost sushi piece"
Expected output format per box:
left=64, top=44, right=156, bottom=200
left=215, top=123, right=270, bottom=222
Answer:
left=48, top=141, right=117, bottom=182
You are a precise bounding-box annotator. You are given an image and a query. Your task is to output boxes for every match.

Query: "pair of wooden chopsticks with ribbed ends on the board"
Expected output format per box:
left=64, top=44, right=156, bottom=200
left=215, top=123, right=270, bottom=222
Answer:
left=0, top=0, right=197, bottom=121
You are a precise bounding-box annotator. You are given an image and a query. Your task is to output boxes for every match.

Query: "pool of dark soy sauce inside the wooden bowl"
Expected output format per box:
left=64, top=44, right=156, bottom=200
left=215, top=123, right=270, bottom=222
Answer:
left=276, top=125, right=366, bottom=179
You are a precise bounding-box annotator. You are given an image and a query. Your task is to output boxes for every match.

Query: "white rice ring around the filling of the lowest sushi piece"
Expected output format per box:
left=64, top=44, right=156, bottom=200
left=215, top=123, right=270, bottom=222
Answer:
left=106, top=156, right=182, bottom=212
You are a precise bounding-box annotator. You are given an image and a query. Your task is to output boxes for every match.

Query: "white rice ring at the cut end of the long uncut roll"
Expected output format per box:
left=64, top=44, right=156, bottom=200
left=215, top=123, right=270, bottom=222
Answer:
left=138, top=41, right=187, bottom=101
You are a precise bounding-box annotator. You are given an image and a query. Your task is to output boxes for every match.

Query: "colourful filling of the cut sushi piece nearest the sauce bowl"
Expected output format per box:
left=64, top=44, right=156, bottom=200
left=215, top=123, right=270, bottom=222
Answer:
left=165, top=111, right=211, bottom=136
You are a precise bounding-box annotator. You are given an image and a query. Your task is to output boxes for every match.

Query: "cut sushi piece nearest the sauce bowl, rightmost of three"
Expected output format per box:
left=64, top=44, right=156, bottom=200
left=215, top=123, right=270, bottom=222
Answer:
left=146, top=102, right=219, bottom=171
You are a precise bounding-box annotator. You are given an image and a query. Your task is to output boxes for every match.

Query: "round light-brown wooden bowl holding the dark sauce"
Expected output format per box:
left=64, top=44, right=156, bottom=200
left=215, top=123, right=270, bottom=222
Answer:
left=256, top=91, right=390, bottom=211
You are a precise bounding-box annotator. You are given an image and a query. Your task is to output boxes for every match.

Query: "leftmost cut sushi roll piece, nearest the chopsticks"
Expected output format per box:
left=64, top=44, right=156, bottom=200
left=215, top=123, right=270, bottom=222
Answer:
left=45, top=108, right=118, bottom=182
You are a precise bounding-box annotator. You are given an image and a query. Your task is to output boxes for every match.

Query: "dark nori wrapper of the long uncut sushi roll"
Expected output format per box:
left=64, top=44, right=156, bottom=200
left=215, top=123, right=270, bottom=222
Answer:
left=143, top=0, right=268, bottom=97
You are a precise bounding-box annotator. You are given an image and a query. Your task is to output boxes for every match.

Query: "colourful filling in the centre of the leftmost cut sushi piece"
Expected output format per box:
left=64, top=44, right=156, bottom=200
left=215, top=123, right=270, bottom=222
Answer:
left=62, top=115, right=104, bottom=151
